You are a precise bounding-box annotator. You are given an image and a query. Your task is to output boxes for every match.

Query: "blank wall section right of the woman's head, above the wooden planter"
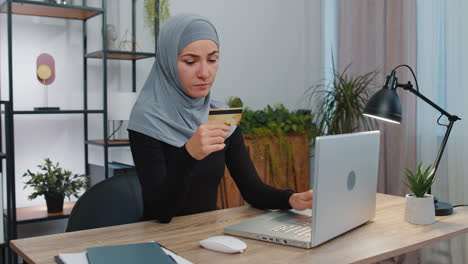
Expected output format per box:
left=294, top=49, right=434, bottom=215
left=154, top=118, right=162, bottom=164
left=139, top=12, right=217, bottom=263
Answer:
left=170, top=0, right=321, bottom=109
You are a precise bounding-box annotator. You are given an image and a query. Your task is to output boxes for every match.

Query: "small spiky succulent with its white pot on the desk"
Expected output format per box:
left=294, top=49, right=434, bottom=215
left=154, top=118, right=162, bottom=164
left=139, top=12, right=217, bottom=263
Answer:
left=403, top=163, right=435, bottom=225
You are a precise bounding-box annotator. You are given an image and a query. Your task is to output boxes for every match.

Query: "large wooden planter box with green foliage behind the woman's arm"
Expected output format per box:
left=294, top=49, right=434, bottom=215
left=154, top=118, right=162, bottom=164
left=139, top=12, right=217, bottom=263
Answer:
left=218, top=97, right=317, bottom=208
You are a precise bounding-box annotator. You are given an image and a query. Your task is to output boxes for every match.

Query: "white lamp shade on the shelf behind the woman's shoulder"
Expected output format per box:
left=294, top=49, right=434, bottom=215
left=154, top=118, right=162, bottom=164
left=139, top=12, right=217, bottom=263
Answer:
left=107, top=92, right=137, bottom=120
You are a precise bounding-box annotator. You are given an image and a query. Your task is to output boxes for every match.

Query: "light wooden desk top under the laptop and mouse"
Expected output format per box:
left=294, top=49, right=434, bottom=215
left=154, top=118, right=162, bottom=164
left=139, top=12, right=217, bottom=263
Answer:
left=11, top=194, right=468, bottom=264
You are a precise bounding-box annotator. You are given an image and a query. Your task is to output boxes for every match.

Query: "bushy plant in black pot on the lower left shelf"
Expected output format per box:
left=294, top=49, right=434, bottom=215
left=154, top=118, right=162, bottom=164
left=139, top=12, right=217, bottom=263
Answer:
left=23, top=158, right=88, bottom=213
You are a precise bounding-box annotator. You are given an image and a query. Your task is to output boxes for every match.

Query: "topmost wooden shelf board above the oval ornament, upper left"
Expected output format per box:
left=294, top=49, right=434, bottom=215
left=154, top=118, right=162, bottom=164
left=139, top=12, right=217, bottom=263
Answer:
left=0, top=0, right=103, bottom=20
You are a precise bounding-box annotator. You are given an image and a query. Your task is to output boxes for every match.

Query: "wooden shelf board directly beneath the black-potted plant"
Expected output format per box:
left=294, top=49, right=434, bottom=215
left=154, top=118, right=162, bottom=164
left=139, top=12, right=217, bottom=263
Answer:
left=16, top=202, right=75, bottom=224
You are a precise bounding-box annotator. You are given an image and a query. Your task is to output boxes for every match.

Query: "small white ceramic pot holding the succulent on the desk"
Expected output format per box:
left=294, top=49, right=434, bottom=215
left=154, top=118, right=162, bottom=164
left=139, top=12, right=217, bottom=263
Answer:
left=405, top=193, right=435, bottom=225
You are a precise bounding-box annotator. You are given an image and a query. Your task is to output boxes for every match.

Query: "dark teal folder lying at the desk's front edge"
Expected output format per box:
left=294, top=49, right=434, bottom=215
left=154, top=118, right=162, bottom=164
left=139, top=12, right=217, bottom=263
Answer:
left=86, top=242, right=176, bottom=264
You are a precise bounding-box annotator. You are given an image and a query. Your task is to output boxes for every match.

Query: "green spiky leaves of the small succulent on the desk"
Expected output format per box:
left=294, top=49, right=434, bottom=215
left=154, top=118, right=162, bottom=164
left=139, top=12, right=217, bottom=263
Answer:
left=403, top=163, right=435, bottom=197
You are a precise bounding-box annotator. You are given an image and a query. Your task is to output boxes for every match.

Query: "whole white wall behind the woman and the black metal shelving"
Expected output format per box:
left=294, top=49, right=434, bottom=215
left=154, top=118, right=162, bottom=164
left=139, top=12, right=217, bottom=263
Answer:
left=0, top=0, right=323, bottom=207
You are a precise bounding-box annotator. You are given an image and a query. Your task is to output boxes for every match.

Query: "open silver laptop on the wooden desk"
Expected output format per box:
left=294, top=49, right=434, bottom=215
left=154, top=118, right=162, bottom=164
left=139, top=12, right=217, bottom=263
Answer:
left=224, top=131, right=380, bottom=248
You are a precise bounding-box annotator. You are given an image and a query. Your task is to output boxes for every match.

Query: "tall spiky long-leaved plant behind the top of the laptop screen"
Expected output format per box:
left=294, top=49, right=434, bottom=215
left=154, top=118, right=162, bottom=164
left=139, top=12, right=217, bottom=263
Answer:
left=305, top=61, right=378, bottom=135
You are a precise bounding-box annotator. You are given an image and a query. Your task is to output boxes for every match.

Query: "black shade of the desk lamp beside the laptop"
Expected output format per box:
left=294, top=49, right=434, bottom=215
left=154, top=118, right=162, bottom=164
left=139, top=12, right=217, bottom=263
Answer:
left=363, top=87, right=401, bottom=123
